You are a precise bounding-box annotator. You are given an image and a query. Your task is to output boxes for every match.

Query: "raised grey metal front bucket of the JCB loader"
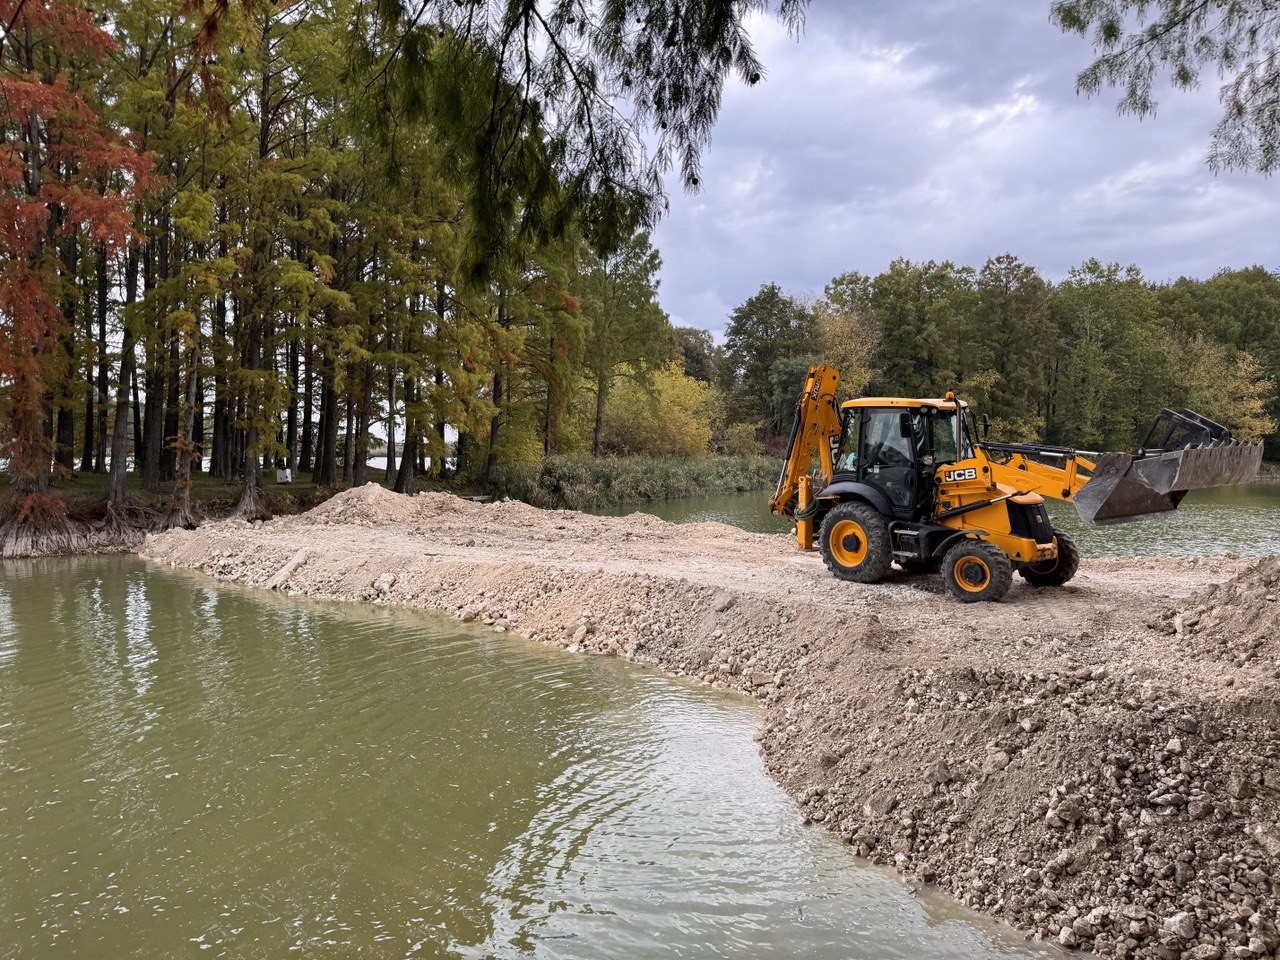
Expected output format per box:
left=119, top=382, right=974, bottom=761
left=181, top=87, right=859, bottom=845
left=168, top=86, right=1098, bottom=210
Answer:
left=1073, top=440, right=1262, bottom=524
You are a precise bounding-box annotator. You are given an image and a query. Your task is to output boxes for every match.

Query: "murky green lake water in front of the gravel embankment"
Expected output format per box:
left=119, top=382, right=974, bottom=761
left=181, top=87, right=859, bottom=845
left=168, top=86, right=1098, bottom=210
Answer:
left=0, top=558, right=1049, bottom=960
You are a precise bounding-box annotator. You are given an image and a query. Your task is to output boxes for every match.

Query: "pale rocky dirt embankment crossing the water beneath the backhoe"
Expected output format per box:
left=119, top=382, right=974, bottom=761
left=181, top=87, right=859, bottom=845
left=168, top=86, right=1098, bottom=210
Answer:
left=142, top=486, right=1280, bottom=960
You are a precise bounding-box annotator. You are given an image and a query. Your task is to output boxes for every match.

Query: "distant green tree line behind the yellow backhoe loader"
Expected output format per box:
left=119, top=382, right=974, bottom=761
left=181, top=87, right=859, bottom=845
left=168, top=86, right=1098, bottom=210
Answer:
left=716, top=253, right=1280, bottom=456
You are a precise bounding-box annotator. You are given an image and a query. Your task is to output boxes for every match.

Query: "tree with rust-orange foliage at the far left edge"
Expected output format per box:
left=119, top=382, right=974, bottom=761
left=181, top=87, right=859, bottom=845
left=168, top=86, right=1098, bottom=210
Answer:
left=0, top=0, right=151, bottom=494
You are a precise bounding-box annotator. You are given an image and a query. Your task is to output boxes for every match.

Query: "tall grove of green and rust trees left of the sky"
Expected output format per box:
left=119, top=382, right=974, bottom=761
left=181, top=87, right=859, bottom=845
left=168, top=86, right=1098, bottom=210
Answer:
left=0, top=0, right=778, bottom=524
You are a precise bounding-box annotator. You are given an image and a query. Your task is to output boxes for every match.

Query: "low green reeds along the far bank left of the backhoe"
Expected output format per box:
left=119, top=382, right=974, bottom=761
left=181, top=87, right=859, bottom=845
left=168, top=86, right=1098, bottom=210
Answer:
left=494, top=456, right=781, bottom=509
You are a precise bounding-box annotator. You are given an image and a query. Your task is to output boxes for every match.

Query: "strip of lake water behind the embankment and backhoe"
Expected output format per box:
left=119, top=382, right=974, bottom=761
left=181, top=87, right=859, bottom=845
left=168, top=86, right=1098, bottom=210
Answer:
left=599, top=484, right=1280, bottom=557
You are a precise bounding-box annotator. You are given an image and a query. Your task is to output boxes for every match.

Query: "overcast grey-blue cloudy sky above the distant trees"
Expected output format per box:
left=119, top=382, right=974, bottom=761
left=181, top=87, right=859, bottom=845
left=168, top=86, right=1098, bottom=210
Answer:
left=653, top=0, right=1280, bottom=337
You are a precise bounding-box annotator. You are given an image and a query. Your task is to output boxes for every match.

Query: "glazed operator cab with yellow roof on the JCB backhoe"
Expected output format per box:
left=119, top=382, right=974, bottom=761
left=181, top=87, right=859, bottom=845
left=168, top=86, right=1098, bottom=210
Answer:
left=835, top=397, right=974, bottom=520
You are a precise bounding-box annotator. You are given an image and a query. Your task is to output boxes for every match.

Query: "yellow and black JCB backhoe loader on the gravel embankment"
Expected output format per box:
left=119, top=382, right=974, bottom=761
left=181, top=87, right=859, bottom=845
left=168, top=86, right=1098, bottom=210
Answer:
left=769, top=366, right=1262, bottom=602
